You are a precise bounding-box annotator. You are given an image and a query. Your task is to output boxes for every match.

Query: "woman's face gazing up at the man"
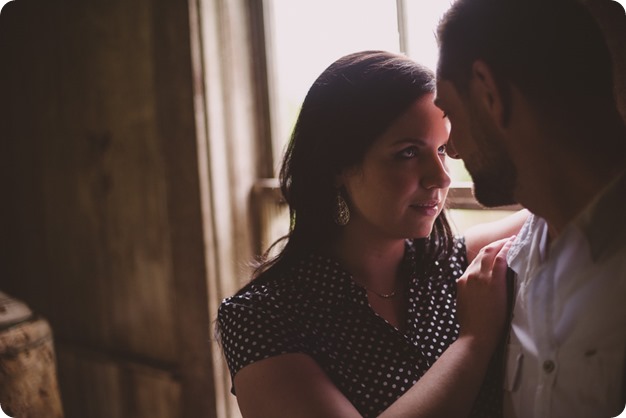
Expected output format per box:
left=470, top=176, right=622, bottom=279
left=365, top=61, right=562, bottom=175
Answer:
left=341, top=94, right=450, bottom=239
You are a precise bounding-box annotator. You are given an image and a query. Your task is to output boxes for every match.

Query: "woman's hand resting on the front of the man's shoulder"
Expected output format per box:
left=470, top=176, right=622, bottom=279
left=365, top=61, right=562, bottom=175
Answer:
left=457, top=237, right=514, bottom=350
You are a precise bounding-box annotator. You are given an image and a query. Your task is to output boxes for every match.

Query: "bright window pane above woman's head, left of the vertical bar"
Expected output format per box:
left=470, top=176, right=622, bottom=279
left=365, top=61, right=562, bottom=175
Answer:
left=267, top=0, right=400, bottom=161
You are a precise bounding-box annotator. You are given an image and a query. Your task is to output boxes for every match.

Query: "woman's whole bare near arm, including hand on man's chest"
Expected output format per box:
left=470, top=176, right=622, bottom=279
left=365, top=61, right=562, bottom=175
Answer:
left=234, top=240, right=509, bottom=418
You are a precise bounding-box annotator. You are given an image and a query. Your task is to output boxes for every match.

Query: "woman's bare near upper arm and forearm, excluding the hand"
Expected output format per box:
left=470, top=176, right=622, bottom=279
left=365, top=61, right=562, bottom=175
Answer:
left=235, top=336, right=492, bottom=418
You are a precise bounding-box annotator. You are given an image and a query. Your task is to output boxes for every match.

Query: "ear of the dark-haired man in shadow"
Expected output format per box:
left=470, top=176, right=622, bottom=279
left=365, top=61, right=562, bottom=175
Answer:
left=470, top=60, right=508, bottom=128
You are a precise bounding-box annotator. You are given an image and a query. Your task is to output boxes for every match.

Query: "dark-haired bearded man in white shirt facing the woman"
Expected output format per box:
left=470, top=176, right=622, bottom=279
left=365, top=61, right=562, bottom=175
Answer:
left=436, top=0, right=626, bottom=418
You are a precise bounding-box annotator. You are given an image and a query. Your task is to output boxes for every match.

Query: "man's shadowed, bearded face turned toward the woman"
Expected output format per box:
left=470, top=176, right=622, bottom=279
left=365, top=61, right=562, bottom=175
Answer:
left=435, top=79, right=517, bottom=207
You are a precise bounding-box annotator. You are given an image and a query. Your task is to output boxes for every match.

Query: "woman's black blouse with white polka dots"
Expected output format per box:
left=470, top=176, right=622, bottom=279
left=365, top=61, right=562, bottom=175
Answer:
left=218, top=239, right=500, bottom=417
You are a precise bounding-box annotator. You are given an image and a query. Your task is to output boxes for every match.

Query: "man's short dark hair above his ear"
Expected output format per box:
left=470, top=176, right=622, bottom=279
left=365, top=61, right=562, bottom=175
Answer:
left=437, top=0, right=613, bottom=113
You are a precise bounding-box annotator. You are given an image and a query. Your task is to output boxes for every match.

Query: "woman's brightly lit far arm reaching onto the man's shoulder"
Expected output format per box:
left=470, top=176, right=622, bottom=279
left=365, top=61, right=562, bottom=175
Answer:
left=465, top=209, right=530, bottom=263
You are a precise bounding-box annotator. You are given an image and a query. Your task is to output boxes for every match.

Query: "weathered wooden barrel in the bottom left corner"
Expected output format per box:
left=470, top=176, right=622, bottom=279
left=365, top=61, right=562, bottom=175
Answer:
left=0, top=292, right=63, bottom=418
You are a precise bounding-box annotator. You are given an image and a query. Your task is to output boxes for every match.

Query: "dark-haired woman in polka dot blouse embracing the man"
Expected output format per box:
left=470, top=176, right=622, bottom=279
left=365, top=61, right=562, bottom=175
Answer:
left=218, top=51, right=525, bottom=418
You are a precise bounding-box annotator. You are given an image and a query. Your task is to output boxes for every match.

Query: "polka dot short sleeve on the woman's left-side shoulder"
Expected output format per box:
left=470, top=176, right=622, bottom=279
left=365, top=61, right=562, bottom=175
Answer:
left=217, top=294, right=307, bottom=393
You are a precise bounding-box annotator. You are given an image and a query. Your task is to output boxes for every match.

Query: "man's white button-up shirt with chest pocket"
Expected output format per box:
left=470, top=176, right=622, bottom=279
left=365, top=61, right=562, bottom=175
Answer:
left=504, top=171, right=626, bottom=418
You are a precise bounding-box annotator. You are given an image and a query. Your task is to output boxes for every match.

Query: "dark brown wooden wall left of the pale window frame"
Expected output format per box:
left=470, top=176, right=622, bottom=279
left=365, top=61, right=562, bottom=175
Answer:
left=0, top=0, right=215, bottom=418
